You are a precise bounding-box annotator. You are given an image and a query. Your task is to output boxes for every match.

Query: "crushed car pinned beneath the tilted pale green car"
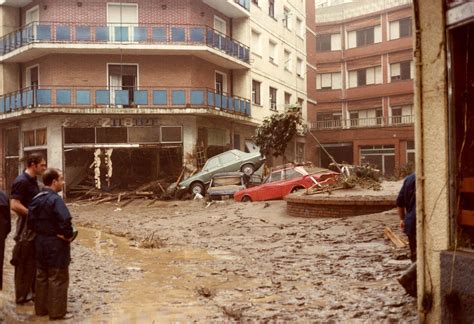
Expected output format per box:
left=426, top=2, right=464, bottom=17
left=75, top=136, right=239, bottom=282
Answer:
left=207, top=172, right=247, bottom=200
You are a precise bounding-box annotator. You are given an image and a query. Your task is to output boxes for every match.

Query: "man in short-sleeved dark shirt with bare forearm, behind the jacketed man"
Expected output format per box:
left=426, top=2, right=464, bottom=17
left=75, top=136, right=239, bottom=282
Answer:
left=10, top=153, right=46, bottom=304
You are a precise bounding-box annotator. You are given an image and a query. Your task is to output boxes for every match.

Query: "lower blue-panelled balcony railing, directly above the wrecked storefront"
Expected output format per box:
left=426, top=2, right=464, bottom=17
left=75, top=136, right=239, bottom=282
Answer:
left=0, top=86, right=250, bottom=116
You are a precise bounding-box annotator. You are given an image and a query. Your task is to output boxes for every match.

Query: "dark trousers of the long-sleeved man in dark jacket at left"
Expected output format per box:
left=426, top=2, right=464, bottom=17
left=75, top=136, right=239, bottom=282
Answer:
left=35, top=267, right=69, bottom=319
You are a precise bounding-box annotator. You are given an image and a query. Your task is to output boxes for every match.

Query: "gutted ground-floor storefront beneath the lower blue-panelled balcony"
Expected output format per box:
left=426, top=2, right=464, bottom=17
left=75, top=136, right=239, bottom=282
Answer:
left=2, top=115, right=254, bottom=197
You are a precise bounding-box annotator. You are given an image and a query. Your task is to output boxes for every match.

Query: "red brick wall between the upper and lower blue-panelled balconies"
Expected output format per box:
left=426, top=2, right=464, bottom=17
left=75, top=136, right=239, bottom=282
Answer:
left=23, top=54, right=230, bottom=88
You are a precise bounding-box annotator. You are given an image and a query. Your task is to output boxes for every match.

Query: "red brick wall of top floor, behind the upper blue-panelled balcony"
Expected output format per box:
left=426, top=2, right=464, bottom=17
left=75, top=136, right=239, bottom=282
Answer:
left=22, top=0, right=230, bottom=33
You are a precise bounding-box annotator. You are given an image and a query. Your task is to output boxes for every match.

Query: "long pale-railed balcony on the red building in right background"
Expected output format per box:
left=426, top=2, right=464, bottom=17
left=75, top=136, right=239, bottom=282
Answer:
left=310, top=115, right=415, bottom=130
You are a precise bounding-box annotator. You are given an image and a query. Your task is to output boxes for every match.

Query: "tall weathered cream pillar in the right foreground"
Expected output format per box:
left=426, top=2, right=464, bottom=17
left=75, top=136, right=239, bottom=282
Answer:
left=415, top=0, right=451, bottom=323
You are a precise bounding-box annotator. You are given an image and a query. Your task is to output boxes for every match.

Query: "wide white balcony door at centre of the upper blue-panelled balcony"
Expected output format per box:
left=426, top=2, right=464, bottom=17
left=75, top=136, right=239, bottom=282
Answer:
left=107, top=3, right=138, bottom=42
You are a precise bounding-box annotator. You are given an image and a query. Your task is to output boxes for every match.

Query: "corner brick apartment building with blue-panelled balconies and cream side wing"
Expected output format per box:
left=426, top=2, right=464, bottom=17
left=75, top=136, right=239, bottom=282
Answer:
left=0, top=0, right=314, bottom=194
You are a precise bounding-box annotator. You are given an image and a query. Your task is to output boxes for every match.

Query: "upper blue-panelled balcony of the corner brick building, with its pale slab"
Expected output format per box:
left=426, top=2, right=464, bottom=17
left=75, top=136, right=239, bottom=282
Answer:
left=0, top=22, right=250, bottom=69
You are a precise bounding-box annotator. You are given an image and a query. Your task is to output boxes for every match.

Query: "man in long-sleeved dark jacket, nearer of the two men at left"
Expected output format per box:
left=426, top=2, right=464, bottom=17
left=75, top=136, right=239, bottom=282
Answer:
left=28, top=169, right=73, bottom=319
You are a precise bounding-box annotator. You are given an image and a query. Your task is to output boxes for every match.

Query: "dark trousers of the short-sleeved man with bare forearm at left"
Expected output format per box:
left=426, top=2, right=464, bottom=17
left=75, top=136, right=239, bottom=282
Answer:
left=15, top=249, right=36, bottom=304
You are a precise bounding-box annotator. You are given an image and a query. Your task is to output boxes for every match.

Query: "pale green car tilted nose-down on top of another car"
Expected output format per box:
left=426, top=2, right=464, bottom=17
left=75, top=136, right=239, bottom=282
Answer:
left=178, top=150, right=265, bottom=195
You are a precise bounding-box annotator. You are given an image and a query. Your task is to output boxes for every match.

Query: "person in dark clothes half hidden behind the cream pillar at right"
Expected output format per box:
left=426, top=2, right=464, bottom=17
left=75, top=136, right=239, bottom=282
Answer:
left=397, top=173, right=416, bottom=297
